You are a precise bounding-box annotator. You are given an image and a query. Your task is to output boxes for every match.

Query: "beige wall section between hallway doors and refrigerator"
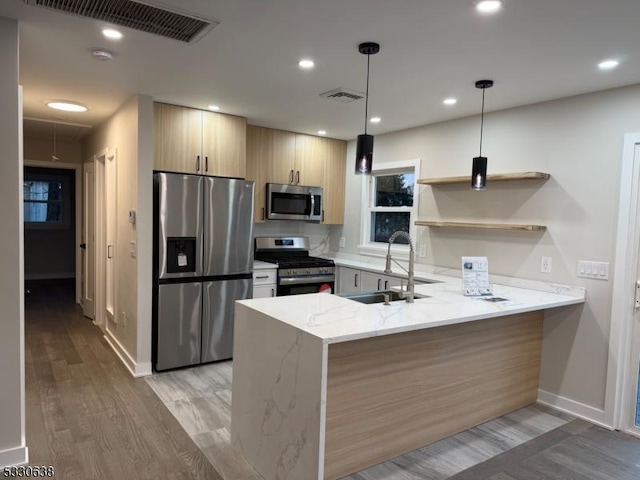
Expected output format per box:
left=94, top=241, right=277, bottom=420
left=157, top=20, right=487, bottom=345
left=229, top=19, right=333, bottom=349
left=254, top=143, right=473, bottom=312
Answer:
left=82, top=95, right=153, bottom=375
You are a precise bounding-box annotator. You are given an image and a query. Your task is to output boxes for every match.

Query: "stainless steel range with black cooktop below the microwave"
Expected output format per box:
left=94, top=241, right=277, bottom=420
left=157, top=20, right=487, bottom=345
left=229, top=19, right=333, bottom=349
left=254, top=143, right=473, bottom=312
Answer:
left=254, top=237, right=336, bottom=296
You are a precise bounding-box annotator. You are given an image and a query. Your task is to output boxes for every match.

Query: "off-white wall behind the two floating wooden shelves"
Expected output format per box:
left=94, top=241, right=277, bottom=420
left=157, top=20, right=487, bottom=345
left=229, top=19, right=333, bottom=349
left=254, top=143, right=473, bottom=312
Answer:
left=337, top=86, right=640, bottom=416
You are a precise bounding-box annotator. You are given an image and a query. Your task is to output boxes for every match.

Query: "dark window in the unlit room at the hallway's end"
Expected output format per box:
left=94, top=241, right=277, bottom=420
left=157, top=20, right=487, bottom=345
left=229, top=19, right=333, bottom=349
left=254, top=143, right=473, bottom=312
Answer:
left=23, top=168, right=70, bottom=227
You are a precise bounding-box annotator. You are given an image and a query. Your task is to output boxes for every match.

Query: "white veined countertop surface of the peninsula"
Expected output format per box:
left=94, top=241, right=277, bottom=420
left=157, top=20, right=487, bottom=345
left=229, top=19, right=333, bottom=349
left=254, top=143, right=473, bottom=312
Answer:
left=238, top=275, right=585, bottom=343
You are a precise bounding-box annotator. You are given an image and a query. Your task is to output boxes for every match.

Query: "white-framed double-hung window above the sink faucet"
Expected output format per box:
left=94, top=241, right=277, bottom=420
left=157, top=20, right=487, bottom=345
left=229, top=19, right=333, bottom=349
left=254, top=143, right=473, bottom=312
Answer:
left=360, top=160, right=420, bottom=255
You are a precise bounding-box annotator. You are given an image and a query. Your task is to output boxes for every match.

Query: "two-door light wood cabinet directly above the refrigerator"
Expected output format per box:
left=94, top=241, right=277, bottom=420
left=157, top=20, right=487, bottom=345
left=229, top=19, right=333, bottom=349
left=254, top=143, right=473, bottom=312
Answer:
left=153, top=103, right=247, bottom=178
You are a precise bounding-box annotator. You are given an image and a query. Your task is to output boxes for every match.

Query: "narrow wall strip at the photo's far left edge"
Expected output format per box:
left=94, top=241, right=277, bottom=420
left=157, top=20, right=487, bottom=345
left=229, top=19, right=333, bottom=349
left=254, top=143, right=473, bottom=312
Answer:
left=0, top=18, right=27, bottom=466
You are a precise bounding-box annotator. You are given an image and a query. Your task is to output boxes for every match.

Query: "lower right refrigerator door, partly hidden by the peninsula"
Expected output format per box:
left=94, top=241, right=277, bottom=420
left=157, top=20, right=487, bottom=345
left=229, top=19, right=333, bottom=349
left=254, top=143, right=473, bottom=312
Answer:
left=202, top=278, right=253, bottom=362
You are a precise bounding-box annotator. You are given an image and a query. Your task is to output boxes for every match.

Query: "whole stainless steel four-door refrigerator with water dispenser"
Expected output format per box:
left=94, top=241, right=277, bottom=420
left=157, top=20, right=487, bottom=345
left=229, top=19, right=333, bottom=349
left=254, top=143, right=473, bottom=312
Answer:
left=153, top=172, right=254, bottom=371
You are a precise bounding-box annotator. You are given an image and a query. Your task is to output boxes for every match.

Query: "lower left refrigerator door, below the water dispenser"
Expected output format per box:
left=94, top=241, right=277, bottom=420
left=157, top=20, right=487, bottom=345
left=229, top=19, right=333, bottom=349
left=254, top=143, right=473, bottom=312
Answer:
left=155, top=282, right=202, bottom=370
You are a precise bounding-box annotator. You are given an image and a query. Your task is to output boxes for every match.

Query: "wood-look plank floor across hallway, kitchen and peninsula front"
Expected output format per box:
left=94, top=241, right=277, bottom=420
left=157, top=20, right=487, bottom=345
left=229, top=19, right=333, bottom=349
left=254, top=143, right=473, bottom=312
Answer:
left=25, top=285, right=640, bottom=480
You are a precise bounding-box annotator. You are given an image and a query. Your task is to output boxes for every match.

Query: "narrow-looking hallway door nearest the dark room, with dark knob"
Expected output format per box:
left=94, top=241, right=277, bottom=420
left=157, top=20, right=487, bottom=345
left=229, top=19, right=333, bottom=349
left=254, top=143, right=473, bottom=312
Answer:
left=80, top=162, right=96, bottom=319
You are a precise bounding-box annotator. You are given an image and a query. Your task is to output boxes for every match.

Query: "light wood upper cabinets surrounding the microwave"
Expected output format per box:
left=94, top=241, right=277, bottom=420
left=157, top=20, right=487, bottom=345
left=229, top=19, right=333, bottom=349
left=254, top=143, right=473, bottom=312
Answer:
left=247, top=125, right=347, bottom=224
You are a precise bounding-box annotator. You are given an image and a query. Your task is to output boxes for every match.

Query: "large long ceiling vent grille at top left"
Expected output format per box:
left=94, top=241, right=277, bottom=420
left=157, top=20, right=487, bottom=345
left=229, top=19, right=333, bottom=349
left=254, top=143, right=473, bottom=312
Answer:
left=23, top=0, right=218, bottom=43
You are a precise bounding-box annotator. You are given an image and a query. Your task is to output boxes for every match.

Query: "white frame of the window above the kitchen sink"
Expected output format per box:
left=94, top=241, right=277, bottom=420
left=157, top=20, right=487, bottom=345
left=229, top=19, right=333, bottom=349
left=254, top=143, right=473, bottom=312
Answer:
left=358, top=158, right=421, bottom=260
